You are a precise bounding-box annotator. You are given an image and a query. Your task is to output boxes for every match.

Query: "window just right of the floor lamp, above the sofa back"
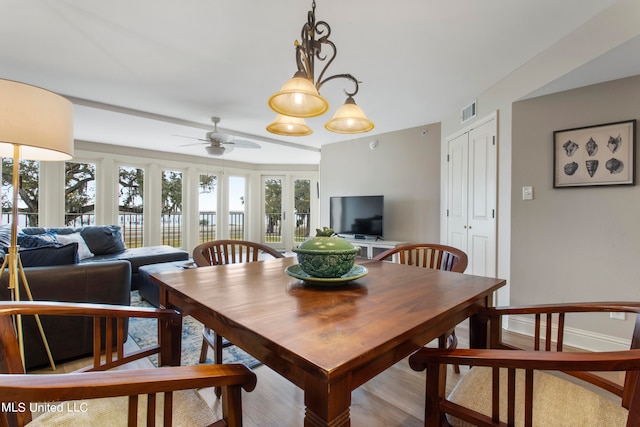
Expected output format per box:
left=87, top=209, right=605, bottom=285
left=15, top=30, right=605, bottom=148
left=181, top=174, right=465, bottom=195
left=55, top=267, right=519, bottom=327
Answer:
left=64, top=162, right=96, bottom=227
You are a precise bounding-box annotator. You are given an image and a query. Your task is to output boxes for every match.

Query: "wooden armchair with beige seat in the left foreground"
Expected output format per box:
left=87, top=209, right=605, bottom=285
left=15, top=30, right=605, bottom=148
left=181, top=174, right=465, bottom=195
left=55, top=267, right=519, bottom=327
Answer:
left=0, top=301, right=256, bottom=427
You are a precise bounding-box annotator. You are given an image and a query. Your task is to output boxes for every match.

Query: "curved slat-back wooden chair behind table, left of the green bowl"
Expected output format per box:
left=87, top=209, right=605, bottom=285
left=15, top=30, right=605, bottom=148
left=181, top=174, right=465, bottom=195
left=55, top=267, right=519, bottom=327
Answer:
left=193, top=240, right=284, bottom=397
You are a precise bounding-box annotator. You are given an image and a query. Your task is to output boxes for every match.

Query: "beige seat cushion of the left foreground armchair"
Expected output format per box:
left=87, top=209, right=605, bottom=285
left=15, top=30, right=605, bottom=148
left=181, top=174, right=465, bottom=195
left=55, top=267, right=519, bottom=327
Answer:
left=28, top=390, right=217, bottom=427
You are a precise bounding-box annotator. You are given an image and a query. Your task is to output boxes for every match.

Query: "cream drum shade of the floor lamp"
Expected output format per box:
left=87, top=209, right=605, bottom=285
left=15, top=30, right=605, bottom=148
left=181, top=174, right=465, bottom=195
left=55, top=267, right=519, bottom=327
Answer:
left=0, top=79, right=73, bottom=161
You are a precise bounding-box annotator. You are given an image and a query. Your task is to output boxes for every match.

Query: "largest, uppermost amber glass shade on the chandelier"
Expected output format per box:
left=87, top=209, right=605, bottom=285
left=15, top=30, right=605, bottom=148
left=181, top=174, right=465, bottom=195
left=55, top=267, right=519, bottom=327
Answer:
left=269, top=71, right=329, bottom=118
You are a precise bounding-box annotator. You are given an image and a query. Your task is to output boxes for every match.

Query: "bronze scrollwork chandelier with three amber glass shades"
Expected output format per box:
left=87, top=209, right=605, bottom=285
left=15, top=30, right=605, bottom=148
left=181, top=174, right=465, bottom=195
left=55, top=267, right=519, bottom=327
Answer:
left=267, top=1, right=374, bottom=136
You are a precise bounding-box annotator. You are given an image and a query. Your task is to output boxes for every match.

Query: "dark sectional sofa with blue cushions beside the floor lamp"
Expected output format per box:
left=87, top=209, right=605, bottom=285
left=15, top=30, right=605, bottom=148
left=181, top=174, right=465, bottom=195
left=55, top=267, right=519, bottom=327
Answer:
left=0, top=225, right=189, bottom=368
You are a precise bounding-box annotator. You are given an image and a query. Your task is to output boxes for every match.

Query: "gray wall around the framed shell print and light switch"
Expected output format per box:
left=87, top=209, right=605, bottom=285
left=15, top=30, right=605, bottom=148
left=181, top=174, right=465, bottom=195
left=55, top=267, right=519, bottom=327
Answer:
left=510, top=76, right=640, bottom=336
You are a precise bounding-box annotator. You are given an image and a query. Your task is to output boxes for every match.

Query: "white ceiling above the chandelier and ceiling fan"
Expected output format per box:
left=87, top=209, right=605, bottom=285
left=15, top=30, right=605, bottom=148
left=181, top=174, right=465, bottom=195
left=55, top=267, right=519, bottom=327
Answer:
left=0, top=0, right=640, bottom=164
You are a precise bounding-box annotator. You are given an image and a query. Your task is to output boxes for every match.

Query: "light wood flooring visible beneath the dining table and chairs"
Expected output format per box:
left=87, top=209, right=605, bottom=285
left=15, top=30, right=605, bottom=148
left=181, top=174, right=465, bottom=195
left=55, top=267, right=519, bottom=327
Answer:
left=31, top=322, right=624, bottom=427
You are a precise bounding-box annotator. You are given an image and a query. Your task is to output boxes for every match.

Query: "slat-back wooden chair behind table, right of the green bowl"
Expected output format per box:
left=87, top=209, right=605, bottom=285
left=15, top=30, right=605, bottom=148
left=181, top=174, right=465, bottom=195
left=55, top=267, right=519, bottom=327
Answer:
left=373, top=243, right=469, bottom=374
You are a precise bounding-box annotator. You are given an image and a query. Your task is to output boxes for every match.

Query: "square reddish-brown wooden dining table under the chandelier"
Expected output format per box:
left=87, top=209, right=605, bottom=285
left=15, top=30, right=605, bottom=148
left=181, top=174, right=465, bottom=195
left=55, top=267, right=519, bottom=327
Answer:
left=151, top=257, right=505, bottom=427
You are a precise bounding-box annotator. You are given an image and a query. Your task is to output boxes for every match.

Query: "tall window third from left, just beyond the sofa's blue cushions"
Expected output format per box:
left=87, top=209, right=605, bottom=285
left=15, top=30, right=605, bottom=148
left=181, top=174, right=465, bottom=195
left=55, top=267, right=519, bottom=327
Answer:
left=118, top=166, right=144, bottom=248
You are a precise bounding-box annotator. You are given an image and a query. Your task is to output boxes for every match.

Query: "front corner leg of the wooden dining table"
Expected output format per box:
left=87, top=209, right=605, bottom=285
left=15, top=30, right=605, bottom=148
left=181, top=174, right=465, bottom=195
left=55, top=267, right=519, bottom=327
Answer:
left=304, top=377, right=351, bottom=427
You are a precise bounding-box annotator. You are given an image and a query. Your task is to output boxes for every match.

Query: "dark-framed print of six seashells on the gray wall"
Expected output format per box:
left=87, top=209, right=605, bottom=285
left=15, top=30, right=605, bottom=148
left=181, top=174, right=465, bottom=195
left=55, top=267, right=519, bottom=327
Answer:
left=553, top=120, right=636, bottom=188
